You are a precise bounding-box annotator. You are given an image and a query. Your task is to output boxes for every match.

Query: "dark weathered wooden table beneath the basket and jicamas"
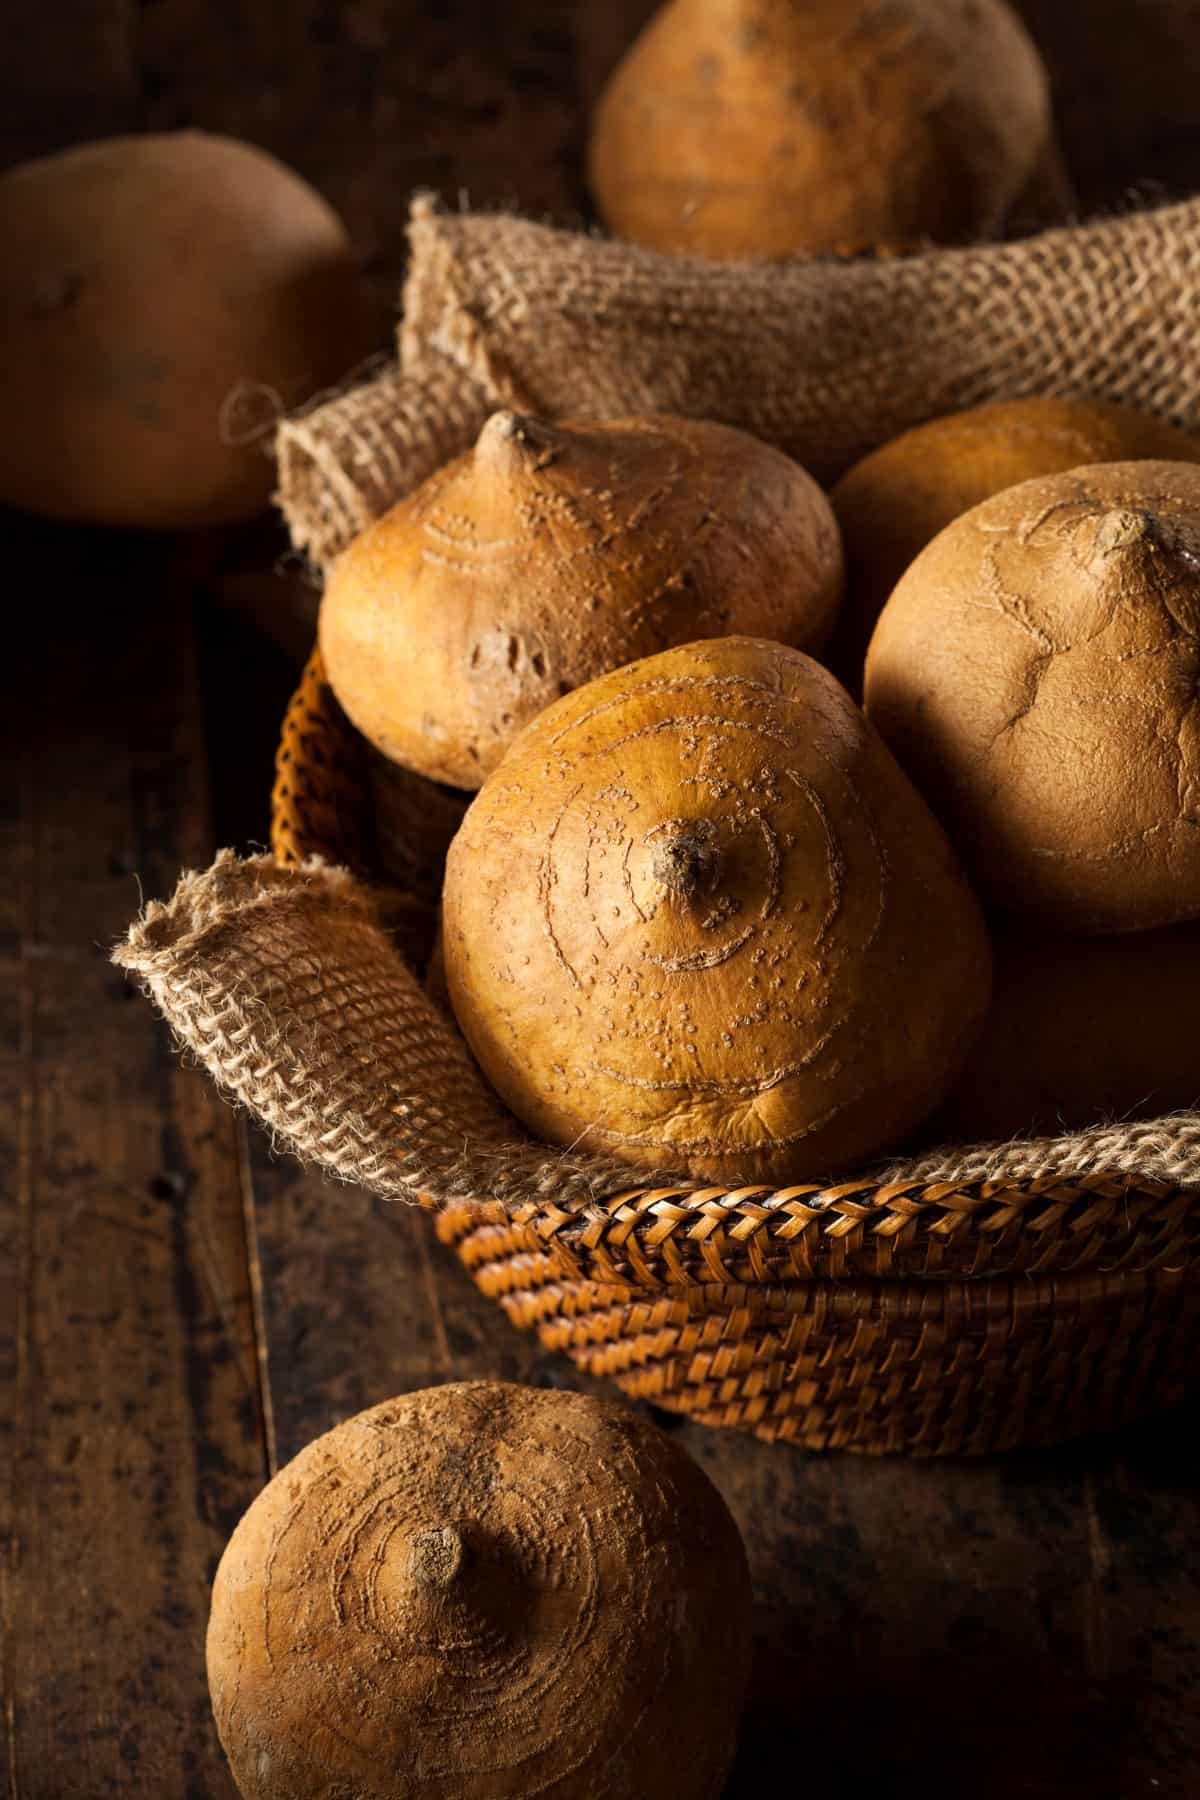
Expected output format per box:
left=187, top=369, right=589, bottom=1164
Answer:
left=0, top=0, right=1200, bottom=1800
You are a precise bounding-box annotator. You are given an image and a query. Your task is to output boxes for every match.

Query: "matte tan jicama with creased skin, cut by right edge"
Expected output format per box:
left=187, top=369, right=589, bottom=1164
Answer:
left=865, top=461, right=1200, bottom=931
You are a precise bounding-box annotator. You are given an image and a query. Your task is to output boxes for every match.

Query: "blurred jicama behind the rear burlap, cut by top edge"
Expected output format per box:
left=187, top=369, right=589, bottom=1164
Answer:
left=590, top=0, right=1051, bottom=257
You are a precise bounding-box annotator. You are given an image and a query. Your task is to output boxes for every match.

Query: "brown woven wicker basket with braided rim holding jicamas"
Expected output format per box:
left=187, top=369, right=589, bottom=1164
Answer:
left=272, top=655, right=1200, bottom=1454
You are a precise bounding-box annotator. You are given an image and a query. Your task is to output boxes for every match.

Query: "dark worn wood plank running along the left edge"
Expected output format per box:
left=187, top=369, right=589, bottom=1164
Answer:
left=0, top=526, right=264, bottom=1800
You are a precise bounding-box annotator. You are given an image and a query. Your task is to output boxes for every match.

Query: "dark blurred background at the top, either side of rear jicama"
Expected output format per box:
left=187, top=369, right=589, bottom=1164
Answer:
left=0, top=0, right=1200, bottom=284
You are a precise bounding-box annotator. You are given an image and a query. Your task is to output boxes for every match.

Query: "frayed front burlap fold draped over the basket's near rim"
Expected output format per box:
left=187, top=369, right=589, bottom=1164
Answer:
left=113, top=851, right=1200, bottom=1211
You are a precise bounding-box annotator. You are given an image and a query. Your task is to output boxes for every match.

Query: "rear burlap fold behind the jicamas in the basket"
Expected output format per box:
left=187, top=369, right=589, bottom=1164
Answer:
left=277, top=200, right=1200, bottom=563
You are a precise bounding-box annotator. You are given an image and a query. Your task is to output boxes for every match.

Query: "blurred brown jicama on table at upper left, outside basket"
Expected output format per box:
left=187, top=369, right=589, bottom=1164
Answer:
left=0, top=131, right=367, bottom=527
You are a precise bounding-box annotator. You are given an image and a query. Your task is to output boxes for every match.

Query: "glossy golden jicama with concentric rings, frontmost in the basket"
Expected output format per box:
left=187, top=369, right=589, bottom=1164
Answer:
left=443, top=637, right=990, bottom=1181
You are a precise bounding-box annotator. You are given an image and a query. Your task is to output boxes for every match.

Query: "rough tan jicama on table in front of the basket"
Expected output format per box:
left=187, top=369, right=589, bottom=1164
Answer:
left=207, top=1381, right=750, bottom=1800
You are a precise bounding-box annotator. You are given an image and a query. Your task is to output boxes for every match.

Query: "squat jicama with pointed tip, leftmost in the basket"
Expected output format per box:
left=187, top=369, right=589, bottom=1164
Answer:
left=320, top=412, right=842, bottom=788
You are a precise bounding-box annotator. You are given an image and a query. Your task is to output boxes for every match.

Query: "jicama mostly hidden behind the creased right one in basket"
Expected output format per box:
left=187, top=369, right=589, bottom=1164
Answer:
left=822, top=396, right=1200, bottom=693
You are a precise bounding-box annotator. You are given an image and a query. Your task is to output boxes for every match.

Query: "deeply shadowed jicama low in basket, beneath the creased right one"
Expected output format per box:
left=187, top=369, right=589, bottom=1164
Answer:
left=932, top=922, right=1200, bottom=1143
